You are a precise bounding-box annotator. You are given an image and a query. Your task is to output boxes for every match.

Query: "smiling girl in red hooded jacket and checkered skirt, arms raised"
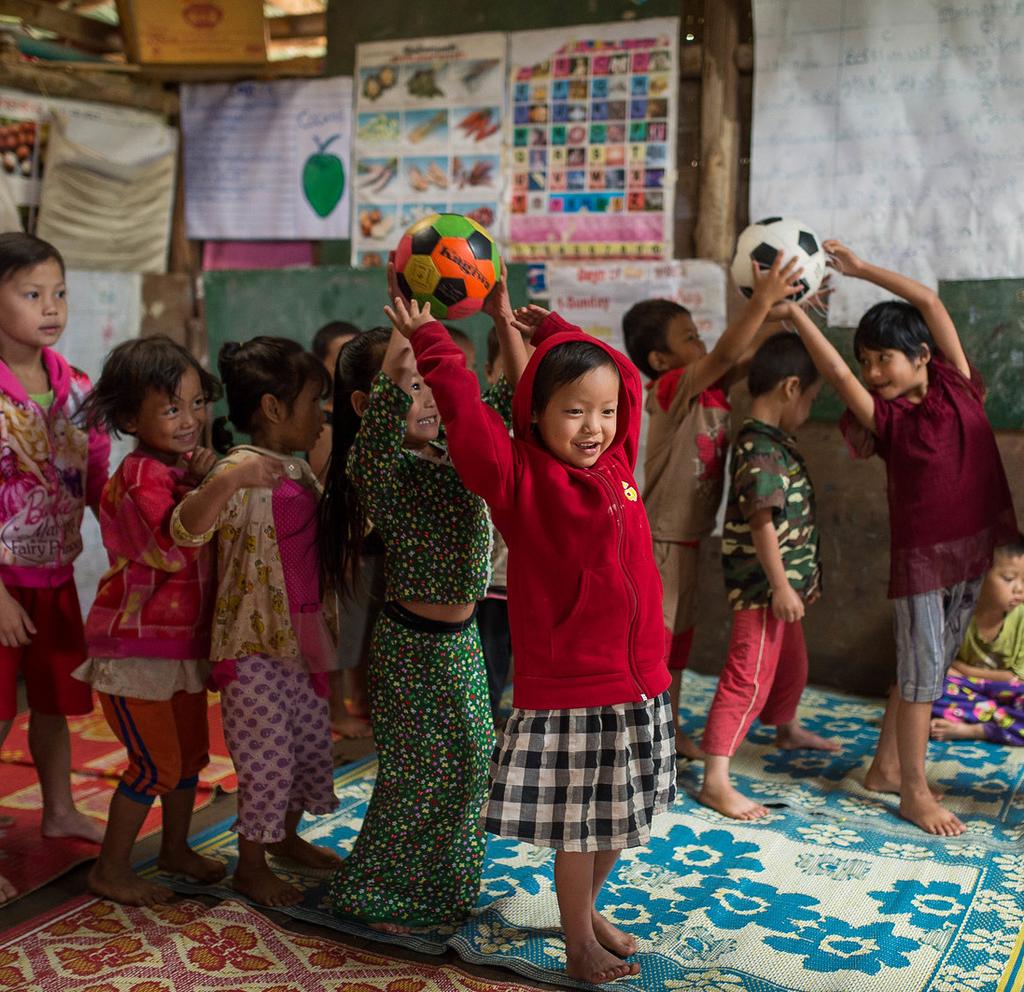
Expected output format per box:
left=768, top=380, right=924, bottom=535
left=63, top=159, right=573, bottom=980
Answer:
left=387, top=282, right=676, bottom=984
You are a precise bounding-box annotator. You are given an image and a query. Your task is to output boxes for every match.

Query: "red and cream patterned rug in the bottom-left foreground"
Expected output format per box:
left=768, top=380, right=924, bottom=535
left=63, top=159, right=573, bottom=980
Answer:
left=0, top=899, right=544, bottom=992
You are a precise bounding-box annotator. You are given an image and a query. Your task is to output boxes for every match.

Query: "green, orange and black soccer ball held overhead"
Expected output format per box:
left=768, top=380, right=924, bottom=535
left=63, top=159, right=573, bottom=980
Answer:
left=394, top=214, right=502, bottom=320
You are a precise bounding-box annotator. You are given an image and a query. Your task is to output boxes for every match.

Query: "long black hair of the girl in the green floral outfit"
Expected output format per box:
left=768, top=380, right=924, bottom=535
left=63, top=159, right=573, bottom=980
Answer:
left=319, top=328, right=391, bottom=593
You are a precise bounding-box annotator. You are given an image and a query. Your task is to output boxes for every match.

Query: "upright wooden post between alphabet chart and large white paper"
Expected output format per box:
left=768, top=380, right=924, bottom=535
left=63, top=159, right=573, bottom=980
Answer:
left=694, top=0, right=739, bottom=262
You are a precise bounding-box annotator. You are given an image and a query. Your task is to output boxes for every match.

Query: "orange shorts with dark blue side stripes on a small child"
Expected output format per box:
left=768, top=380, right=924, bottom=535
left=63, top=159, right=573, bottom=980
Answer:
left=96, top=687, right=210, bottom=804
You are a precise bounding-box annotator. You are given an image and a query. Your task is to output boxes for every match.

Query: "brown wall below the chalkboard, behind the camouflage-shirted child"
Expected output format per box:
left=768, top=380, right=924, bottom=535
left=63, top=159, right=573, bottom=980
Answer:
left=691, top=421, right=1024, bottom=695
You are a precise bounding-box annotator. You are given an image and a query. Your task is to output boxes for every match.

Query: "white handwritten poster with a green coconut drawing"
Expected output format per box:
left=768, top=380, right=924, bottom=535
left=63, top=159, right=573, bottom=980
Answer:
left=181, top=76, right=352, bottom=241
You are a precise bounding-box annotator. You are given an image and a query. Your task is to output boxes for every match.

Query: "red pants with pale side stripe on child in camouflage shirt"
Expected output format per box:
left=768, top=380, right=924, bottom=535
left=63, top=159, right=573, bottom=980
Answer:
left=701, top=607, right=807, bottom=758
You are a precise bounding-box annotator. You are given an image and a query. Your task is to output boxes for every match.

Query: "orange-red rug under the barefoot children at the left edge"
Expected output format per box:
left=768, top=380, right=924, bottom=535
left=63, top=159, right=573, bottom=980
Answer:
left=0, top=695, right=238, bottom=900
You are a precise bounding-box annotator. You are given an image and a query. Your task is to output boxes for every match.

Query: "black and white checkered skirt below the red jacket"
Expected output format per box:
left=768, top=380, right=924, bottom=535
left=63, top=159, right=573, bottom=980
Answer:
left=483, top=692, right=676, bottom=852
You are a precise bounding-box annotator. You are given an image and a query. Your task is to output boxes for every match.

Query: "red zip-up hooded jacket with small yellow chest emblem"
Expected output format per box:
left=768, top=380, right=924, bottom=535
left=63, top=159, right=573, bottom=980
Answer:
left=412, top=313, right=670, bottom=709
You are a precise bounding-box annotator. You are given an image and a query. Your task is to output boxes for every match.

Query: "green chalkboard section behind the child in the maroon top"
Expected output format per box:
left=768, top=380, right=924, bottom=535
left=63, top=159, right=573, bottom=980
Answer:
left=812, top=279, right=1024, bottom=430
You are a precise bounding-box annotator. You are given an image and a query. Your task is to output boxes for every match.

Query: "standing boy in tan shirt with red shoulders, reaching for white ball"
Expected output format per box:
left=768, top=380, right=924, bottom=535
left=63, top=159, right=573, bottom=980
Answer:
left=623, top=255, right=800, bottom=758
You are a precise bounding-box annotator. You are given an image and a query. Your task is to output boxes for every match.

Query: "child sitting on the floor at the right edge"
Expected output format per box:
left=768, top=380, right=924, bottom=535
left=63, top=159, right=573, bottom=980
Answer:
left=931, top=537, right=1024, bottom=745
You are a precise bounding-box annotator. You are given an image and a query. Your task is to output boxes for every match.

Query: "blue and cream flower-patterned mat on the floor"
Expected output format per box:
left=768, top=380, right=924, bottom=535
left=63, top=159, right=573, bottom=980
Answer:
left=151, top=674, right=1024, bottom=992
